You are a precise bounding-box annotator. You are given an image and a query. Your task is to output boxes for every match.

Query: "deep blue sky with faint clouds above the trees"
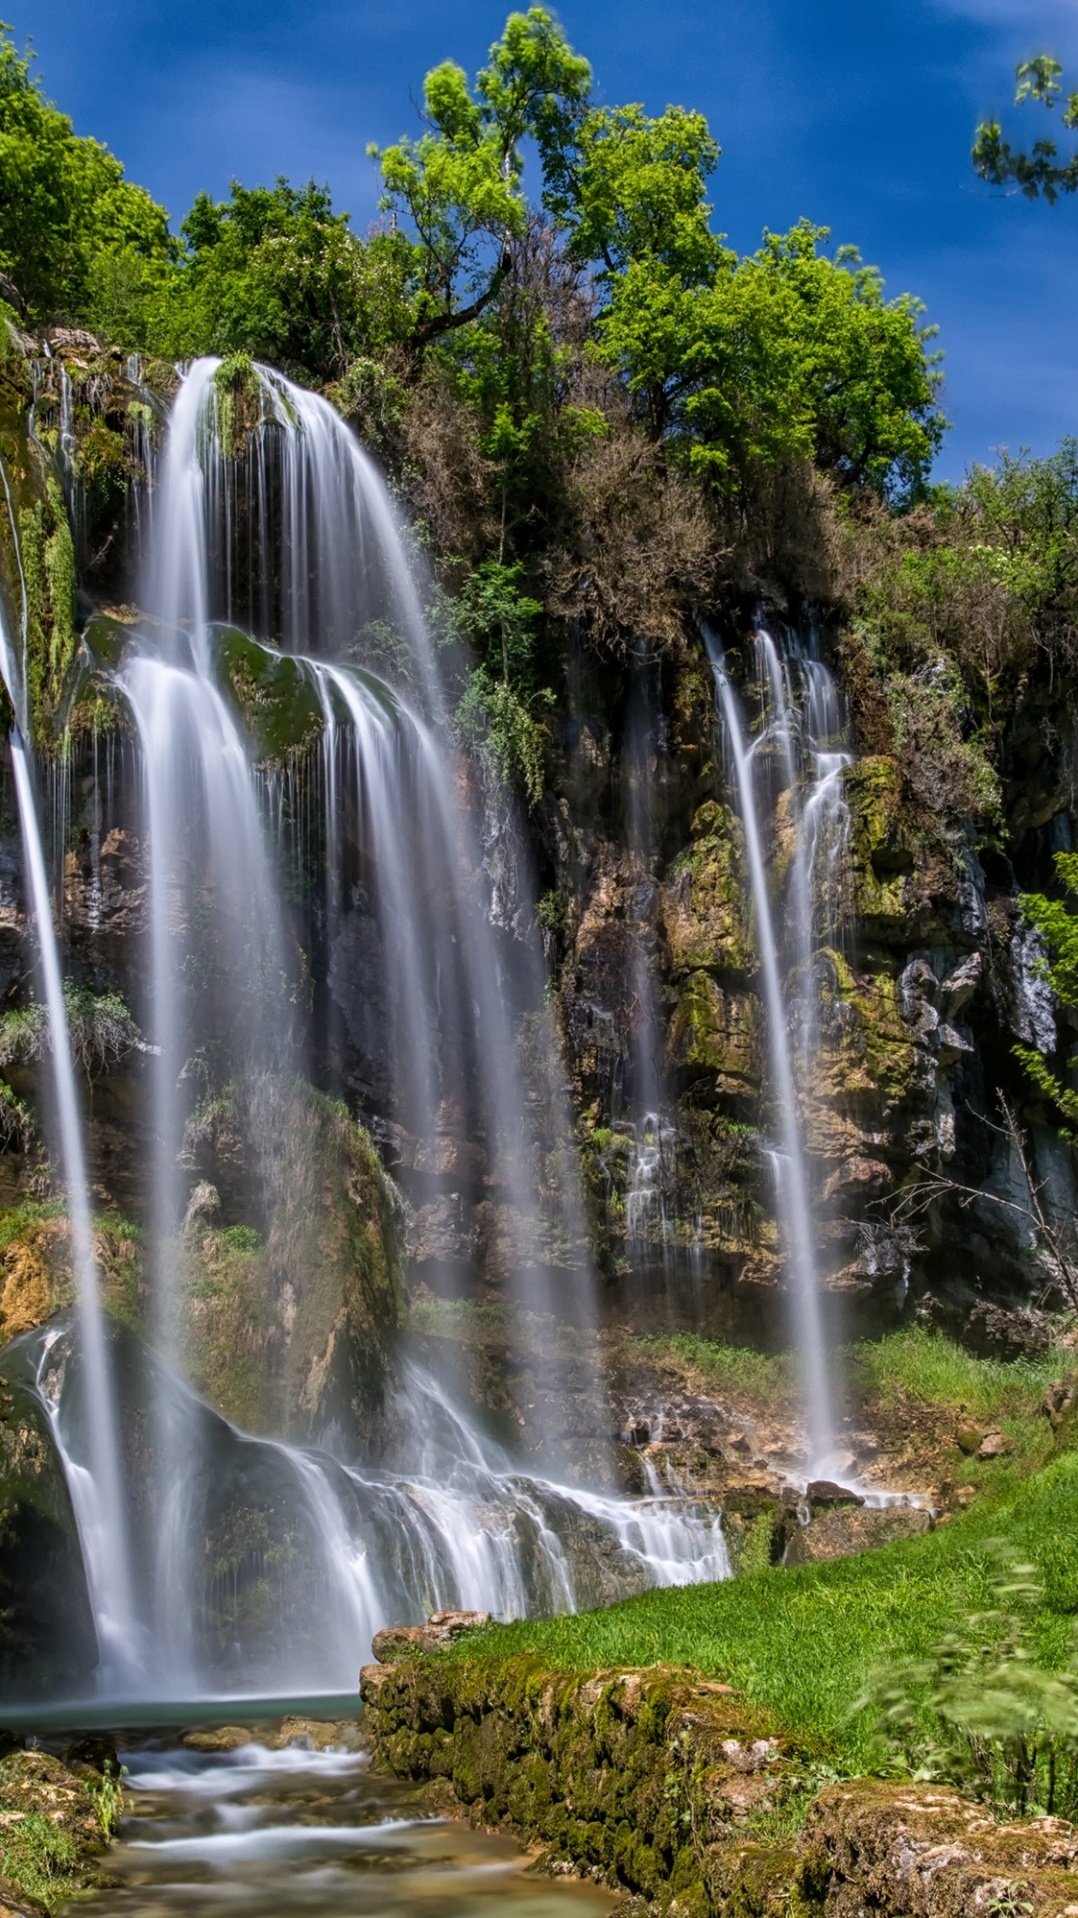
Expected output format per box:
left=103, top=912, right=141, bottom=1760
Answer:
left=14, top=0, right=1078, bottom=478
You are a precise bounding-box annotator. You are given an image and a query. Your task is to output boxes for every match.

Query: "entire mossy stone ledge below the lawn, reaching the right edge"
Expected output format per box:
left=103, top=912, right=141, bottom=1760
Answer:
left=361, top=1634, right=1078, bottom=1918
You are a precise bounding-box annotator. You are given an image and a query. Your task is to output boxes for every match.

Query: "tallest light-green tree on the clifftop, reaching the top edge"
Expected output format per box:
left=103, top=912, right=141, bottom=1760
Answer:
left=368, top=8, right=591, bottom=349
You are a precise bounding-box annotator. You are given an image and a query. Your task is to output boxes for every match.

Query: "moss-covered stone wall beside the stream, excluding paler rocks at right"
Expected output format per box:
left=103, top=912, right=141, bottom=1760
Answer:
left=361, top=1655, right=796, bottom=1914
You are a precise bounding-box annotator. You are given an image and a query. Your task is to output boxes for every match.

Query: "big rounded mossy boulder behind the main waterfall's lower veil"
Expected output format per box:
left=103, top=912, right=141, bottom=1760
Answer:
left=182, top=1076, right=405, bottom=1437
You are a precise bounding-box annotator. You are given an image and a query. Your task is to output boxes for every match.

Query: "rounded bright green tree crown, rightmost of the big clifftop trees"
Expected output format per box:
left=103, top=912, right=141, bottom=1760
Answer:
left=598, top=221, right=944, bottom=497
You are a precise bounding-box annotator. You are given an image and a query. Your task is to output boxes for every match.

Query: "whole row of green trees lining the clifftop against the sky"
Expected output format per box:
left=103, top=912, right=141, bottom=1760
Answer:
left=0, top=6, right=939, bottom=502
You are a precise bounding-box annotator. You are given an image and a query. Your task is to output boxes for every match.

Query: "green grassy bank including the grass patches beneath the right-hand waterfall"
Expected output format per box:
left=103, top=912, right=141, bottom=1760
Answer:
left=433, top=1331, right=1078, bottom=1770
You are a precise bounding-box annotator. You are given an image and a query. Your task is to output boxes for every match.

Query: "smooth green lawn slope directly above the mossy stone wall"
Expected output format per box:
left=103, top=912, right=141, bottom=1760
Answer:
left=447, top=1452, right=1078, bottom=1772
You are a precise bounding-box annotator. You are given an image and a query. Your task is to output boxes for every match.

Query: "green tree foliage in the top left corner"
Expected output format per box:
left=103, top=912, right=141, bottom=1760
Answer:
left=0, top=25, right=171, bottom=320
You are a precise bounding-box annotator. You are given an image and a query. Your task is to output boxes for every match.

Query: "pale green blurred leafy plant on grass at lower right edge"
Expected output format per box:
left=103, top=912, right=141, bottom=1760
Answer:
left=855, top=1540, right=1078, bottom=1816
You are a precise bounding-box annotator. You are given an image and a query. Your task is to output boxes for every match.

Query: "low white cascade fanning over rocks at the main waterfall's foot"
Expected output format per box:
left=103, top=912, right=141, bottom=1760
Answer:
left=19, top=1322, right=731, bottom=1699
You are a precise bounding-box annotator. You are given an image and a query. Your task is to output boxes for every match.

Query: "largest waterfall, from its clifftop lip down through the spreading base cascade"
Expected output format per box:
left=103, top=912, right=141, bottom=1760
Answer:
left=0, top=361, right=729, bottom=1696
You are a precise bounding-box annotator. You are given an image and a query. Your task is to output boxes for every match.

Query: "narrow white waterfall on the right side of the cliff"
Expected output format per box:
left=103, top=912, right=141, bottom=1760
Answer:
left=706, top=629, right=848, bottom=1473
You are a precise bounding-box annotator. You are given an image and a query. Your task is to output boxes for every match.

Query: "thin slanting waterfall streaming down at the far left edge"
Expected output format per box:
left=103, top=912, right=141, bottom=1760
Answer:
left=0, top=491, right=142, bottom=1684
